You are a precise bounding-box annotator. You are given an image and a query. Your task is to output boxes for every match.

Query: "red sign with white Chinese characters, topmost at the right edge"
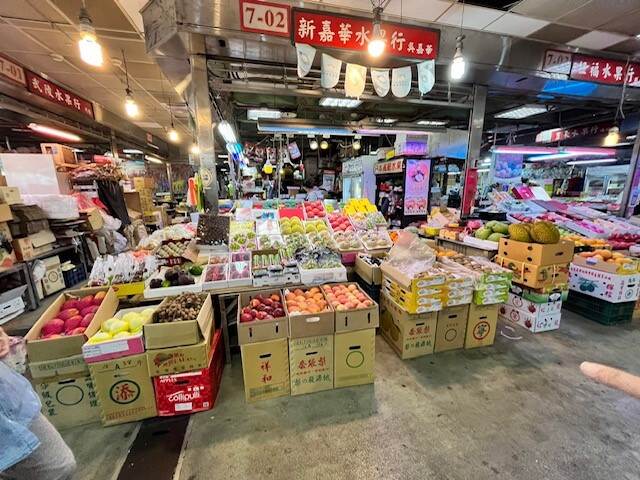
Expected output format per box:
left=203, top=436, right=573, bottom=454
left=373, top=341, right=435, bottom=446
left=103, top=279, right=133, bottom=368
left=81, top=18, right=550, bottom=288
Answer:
left=569, top=54, right=640, bottom=87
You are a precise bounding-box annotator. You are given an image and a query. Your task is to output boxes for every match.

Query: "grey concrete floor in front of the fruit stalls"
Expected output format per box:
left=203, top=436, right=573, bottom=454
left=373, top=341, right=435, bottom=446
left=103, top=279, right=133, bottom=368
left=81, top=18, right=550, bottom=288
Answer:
left=53, top=311, right=640, bottom=480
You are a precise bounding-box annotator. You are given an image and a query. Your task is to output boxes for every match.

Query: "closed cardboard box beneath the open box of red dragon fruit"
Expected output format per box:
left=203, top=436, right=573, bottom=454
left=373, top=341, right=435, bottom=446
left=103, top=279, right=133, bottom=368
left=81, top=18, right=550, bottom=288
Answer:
left=34, top=372, right=100, bottom=429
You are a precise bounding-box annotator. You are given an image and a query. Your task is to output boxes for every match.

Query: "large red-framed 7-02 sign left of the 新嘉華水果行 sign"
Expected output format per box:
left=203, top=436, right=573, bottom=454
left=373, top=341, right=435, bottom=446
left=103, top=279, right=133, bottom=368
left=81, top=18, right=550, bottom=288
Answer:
left=240, top=0, right=291, bottom=37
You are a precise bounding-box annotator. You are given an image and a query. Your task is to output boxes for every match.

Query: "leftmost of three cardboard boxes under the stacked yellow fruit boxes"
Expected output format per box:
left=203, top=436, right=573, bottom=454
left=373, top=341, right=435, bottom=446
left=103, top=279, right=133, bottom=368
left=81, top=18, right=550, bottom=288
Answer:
left=380, top=294, right=438, bottom=360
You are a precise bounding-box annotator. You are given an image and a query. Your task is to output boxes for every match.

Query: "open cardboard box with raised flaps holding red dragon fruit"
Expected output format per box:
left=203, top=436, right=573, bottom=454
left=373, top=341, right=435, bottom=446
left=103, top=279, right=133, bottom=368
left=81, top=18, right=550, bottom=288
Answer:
left=25, top=289, right=118, bottom=362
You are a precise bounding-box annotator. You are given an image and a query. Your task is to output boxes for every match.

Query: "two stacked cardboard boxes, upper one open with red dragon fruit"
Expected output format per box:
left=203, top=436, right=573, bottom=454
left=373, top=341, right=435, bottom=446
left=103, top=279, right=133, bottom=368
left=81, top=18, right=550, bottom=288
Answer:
left=25, top=289, right=118, bottom=429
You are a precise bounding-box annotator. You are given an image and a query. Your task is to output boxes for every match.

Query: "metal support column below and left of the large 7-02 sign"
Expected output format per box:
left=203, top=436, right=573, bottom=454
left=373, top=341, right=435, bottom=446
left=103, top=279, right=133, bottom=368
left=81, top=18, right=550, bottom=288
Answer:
left=189, top=34, right=218, bottom=215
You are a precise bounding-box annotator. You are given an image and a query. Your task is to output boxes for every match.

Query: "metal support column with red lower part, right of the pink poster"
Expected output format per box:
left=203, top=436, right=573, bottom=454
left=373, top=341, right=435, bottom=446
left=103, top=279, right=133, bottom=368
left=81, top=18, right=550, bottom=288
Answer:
left=460, top=85, right=487, bottom=217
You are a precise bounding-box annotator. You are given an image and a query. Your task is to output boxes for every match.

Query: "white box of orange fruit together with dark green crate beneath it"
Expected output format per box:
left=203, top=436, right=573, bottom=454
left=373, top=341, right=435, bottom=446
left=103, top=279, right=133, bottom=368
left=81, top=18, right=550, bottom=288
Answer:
left=565, top=250, right=640, bottom=325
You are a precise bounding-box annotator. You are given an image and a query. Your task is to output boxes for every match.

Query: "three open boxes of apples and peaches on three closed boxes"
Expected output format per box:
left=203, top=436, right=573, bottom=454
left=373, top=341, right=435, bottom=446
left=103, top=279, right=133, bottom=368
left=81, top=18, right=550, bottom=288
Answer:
left=238, top=283, right=379, bottom=402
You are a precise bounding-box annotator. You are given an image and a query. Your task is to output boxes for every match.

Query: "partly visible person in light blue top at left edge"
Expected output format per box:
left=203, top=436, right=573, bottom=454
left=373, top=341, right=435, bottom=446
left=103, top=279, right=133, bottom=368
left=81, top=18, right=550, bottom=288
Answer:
left=0, top=328, right=76, bottom=480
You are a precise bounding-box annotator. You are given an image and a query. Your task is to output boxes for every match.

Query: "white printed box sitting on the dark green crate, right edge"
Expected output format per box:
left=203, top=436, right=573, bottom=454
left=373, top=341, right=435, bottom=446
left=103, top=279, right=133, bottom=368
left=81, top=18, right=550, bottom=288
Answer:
left=569, top=263, right=640, bottom=303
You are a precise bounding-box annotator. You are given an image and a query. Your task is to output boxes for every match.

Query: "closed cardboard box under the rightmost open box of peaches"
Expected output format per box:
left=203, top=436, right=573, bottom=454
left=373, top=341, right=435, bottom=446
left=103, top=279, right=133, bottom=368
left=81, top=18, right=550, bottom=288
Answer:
left=333, top=328, right=376, bottom=388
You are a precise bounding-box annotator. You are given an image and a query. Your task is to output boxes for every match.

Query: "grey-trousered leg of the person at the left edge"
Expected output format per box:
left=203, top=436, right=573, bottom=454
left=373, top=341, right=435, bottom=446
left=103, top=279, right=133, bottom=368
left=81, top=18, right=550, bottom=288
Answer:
left=0, top=414, right=76, bottom=480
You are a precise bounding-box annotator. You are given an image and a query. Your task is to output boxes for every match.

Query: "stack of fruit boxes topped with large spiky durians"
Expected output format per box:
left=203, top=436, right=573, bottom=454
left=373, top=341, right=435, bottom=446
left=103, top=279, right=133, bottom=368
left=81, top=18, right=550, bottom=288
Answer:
left=495, top=221, right=574, bottom=333
